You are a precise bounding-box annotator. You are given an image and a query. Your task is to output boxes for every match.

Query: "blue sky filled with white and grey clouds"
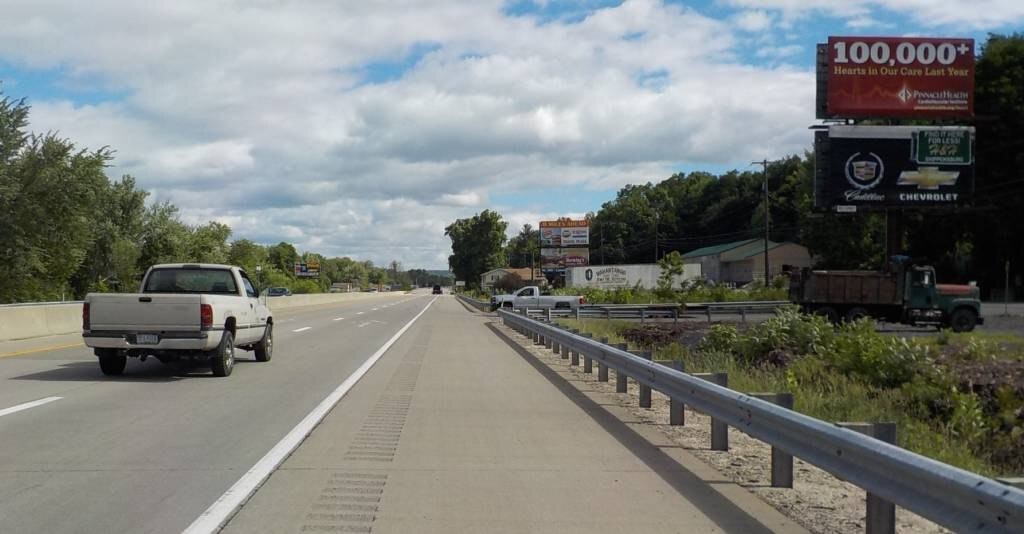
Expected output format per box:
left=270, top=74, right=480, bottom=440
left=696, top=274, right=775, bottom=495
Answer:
left=0, top=0, right=1024, bottom=269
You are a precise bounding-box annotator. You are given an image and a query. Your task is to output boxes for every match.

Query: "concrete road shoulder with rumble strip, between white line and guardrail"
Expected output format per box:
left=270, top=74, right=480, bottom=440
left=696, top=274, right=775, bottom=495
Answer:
left=225, top=298, right=803, bottom=534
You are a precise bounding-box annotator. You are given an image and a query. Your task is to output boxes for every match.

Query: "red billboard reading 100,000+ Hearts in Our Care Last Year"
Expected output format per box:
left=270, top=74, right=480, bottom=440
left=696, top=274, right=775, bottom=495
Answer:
left=826, top=37, right=974, bottom=118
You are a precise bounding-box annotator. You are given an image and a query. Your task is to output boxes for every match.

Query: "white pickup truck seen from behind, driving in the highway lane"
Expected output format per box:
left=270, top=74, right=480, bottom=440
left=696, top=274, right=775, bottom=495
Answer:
left=82, top=263, right=273, bottom=376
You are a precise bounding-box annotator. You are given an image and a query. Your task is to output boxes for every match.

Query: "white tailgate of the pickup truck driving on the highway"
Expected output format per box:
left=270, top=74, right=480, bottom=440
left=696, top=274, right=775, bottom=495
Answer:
left=88, top=293, right=201, bottom=332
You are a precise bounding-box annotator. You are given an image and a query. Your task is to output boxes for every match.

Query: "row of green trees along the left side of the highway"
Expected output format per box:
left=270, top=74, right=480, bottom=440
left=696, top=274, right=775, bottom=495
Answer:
left=0, top=94, right=449, bottom=303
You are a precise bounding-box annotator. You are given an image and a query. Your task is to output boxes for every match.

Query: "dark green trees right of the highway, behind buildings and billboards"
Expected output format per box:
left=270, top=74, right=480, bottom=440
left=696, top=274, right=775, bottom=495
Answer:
left=445, top=34, right=1024, bottom=296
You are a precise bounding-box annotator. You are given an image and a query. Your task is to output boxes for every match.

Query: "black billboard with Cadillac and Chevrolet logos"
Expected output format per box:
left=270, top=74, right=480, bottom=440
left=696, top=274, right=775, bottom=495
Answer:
left=815, top=125, right=974, bottom=212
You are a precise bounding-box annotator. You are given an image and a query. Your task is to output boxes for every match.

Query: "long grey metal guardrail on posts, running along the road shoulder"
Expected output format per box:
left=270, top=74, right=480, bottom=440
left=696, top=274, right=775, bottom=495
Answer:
left=499, top=310, right=1024, bottom=533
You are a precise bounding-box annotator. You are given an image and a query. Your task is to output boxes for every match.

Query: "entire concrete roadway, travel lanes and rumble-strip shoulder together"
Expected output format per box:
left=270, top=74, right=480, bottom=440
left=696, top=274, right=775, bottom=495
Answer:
left=0, top=294, right=802, bottom=533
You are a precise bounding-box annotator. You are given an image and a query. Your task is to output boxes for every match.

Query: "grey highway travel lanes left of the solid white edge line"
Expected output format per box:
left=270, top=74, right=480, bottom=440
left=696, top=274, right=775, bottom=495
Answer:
left=0, top=293, right=432, bottom=533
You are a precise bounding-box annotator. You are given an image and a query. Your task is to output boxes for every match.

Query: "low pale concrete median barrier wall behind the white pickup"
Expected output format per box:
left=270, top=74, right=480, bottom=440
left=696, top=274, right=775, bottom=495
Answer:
left=0, top=292, right=400, bottom=341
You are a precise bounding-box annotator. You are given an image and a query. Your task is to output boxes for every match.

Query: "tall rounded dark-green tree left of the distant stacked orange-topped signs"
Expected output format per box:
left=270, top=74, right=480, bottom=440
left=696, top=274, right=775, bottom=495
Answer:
left=444, top=209, right=508, bottom=288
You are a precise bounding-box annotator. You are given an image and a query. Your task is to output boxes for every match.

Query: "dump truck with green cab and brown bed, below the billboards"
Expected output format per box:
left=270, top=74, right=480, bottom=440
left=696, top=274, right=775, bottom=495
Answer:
left=790, top=259, right=984, bottom=332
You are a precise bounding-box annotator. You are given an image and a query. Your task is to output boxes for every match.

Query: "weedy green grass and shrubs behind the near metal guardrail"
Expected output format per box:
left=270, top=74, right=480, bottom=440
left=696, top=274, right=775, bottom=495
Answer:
left=561, top=310, right=1024, bottom=477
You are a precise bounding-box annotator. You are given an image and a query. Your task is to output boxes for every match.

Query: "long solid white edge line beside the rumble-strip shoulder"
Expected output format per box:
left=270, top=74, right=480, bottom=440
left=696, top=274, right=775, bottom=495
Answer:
left=182, top=298, right=436, bottom=534
